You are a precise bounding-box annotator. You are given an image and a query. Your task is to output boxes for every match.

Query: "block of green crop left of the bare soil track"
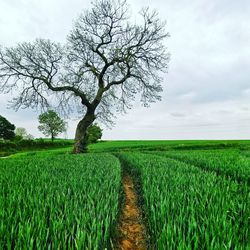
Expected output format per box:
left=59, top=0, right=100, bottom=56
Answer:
left=0, top=154, right=121, bottom=249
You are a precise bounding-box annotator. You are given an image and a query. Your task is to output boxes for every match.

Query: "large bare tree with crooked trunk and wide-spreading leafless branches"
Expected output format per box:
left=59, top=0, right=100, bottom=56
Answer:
left=0, top=0, right=169, bottom=153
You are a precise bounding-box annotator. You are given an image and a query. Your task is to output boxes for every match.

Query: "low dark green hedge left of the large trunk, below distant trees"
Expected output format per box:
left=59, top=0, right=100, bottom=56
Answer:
left=0, top=139, right=74, bottom=157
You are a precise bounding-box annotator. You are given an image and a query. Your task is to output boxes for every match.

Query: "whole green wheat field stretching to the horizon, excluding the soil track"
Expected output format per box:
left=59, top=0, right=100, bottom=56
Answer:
left=0, top=141, right=250, bottom=250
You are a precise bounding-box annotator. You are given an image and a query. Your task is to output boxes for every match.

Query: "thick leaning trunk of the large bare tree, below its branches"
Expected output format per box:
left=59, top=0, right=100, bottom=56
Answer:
left=74, top=111, right=96, bottom=154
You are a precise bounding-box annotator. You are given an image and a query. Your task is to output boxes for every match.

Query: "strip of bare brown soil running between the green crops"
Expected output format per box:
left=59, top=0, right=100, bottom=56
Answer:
left=117, top=174, right=147, bottom=250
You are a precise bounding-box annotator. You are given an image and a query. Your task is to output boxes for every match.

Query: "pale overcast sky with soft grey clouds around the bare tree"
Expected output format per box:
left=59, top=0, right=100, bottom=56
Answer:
left=0, top=0, right=250, bottom=139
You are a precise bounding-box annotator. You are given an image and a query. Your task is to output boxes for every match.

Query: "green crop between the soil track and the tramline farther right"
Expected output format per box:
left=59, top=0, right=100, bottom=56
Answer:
left=120, top=153, right=250, bottom=249
